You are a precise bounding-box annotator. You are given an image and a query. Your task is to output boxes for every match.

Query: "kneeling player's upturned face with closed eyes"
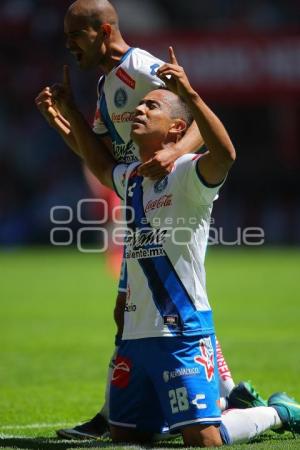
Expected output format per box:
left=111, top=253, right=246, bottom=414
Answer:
left=131, top=89, right=173, bottom=146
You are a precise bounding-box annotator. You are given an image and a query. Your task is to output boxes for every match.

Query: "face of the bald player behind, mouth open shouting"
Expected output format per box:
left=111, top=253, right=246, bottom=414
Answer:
left=64, top=14, right=105, bottom=69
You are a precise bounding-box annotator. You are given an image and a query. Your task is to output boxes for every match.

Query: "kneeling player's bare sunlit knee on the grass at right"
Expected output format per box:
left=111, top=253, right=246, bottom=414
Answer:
left=181, top=425, right=223, bottom=447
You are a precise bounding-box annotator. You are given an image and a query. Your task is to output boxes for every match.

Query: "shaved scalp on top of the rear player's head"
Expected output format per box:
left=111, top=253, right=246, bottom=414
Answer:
left=66, top=0, right=119, bottom=29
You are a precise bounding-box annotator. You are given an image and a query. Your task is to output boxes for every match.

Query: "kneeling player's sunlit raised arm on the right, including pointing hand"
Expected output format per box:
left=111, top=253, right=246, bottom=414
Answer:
left=157, top=47, right=236, bottom=185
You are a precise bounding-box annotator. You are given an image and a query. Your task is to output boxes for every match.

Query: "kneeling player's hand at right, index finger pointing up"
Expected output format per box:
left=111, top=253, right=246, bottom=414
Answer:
left=156, top=47, right=195, bottom=98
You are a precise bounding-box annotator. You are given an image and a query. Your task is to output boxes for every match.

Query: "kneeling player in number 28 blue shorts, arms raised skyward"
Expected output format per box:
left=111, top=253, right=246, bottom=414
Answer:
left=50, top=45, right=300, bottom=447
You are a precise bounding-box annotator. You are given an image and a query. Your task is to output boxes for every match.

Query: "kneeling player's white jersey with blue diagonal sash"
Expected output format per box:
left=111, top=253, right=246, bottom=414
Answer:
left=113, top=154, right=220, bottom=339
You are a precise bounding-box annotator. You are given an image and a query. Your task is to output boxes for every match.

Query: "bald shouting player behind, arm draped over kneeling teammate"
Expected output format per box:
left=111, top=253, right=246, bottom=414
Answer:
left=36, top=0, right=260, bottom=438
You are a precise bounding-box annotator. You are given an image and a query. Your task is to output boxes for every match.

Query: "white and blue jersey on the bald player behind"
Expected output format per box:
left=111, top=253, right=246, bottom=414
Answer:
left=93, top=48, right=164, bottom=163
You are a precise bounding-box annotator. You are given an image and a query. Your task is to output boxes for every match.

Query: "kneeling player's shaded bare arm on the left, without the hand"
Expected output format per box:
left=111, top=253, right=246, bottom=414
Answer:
left=68, top=109, right=116, bottom=188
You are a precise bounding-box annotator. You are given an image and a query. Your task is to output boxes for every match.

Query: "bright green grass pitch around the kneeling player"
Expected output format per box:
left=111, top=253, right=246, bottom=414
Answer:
left=0, top=249, right=300, bottom=450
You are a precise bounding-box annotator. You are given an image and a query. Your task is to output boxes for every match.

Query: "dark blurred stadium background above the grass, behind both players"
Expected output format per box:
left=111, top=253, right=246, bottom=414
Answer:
left=0, top=0, right=300, bottom=248
